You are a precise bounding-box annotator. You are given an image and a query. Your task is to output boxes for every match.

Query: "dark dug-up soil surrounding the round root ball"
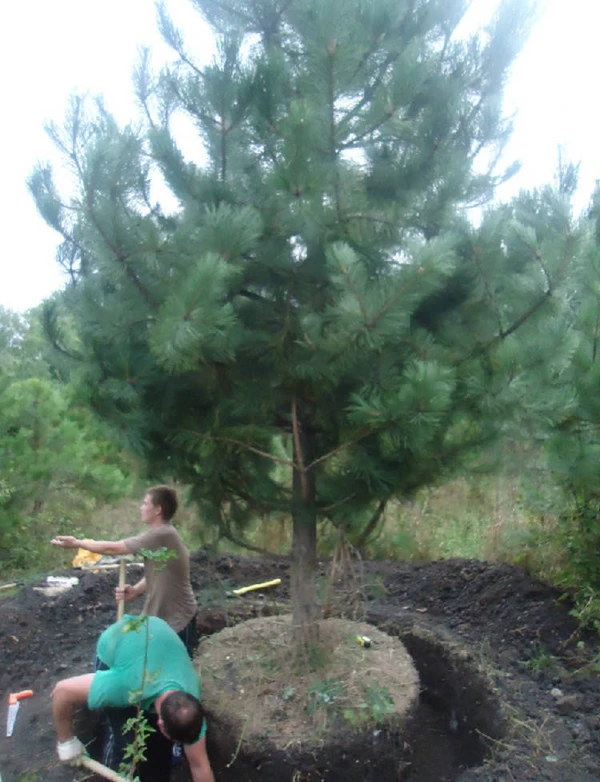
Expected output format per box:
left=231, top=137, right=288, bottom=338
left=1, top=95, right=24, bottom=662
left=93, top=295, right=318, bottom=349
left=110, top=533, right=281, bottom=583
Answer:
left=0, top=554, right=600, bottom=782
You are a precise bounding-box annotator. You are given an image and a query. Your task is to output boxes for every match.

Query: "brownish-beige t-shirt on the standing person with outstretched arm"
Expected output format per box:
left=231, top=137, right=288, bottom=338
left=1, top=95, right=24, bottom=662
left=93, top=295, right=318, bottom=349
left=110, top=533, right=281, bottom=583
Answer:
left=124, top=524, right=198, bottom=633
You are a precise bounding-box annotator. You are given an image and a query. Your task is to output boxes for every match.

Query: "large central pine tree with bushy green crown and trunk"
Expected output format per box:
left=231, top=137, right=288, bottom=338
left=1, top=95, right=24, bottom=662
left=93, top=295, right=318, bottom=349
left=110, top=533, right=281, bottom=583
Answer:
left=31, top=0, right=564, bottom=641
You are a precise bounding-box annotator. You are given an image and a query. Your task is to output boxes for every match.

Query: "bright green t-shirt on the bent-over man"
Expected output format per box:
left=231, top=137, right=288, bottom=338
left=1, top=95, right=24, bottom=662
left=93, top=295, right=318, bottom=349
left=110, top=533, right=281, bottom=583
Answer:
left=88, top=616, right=200, bottom=711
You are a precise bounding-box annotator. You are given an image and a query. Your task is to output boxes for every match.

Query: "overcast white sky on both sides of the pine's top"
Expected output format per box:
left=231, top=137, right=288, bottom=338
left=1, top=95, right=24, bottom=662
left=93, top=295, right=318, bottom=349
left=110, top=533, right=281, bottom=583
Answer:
left=0, top=0, right=600, bottom=311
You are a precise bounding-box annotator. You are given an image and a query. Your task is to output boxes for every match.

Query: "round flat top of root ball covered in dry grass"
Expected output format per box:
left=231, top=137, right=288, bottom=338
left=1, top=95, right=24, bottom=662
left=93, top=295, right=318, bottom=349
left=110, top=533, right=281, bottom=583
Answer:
left=196, top=615, right=419, bottom=750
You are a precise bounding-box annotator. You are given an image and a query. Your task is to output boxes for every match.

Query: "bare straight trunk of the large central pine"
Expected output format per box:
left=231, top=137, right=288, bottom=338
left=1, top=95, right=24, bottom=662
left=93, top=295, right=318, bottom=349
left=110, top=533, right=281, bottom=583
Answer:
left=291, top=426, right=318, bottom=659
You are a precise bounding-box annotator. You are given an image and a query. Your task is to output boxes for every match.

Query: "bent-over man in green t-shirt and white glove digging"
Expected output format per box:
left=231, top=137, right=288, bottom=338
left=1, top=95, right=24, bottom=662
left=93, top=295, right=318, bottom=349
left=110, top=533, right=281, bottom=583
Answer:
left=52, top=616, right=214, bottom=782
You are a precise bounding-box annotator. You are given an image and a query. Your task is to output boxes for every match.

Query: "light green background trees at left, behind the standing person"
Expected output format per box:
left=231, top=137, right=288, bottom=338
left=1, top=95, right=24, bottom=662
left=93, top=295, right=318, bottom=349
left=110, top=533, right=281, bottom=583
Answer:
left=0, top=308, right=132, bottom=573
